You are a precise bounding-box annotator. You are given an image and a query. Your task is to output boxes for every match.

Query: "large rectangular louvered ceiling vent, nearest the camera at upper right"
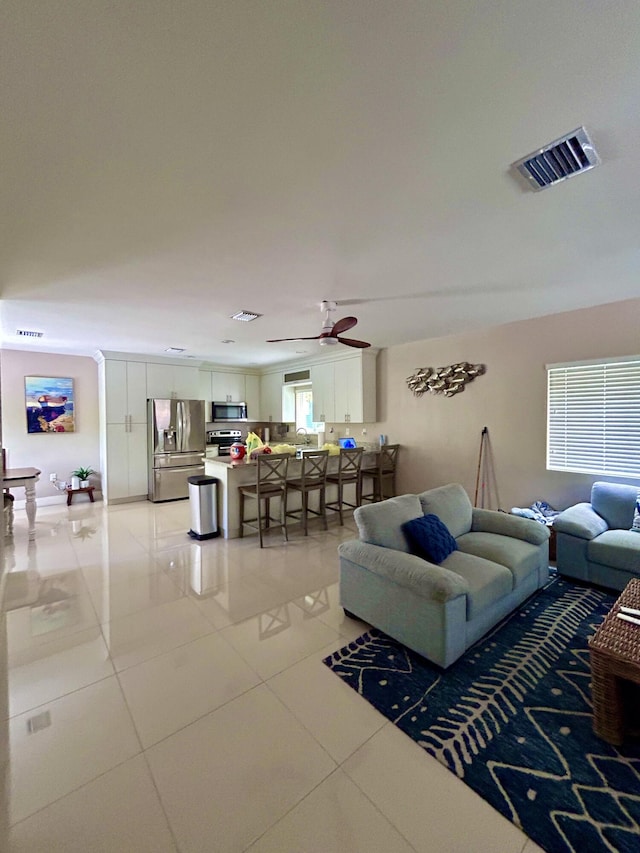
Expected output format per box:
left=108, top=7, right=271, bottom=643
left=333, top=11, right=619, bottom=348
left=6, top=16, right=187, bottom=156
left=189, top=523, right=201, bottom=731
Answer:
left=512, top=127, right=602, bottom=191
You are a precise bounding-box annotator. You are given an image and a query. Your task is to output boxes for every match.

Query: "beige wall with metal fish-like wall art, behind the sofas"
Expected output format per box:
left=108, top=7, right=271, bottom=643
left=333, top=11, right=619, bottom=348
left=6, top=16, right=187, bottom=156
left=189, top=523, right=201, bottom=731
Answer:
left=376, top=299, right=640, bottom=511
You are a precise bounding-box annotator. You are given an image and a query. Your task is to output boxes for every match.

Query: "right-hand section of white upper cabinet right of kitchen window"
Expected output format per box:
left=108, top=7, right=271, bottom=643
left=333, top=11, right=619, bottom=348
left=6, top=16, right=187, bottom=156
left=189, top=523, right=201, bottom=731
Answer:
left=324, top=351, right=377, bottom=424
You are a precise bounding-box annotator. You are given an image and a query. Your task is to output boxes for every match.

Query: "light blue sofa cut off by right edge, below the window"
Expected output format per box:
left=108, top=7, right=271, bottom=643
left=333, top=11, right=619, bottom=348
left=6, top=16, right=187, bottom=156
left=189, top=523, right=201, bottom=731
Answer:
left=553, top=483, right=640, bottom=590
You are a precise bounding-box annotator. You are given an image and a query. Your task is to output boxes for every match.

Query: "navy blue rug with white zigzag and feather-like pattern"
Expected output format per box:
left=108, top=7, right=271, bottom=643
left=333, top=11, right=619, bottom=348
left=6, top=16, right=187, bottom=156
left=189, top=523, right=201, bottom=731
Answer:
left=324, top=579, right=640, bottom=853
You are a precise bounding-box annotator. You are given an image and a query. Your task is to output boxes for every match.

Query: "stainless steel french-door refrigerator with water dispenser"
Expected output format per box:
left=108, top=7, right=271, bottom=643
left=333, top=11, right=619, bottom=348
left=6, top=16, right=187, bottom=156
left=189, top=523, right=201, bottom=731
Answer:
left=147, top=400, right=205, bottom=502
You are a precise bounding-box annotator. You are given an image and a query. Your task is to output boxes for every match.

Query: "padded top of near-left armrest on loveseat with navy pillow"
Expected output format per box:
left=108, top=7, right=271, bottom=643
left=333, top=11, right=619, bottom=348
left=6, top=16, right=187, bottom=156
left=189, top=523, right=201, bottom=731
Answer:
left=338, top=539, right=469, bottom=603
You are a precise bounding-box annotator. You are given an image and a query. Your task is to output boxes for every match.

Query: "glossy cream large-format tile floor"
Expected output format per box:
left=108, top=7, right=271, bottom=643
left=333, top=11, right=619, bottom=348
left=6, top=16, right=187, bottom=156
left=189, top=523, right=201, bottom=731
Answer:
left=0, top=501, right=540, bottom=853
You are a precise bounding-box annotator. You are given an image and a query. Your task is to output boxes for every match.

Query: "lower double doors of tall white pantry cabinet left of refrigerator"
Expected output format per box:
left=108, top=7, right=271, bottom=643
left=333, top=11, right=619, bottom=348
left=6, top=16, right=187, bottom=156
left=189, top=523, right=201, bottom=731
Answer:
left=102, top=423, right=148, bottom=501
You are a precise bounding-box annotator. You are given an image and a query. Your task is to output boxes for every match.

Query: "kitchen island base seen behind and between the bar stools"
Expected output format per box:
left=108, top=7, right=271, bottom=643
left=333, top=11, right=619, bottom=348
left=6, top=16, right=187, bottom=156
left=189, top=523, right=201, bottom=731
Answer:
left=204, top=450, right=380, bottom=539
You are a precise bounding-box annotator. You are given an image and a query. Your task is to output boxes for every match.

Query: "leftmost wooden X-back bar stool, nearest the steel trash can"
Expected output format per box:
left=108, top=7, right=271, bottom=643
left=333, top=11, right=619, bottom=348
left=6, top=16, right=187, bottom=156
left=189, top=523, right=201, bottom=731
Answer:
left=238, top=453, right=290, bottom=548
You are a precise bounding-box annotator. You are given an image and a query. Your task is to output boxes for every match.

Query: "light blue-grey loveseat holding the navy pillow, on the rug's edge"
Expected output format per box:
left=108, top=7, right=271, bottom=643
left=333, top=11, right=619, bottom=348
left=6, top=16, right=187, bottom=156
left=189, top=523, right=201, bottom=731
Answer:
left=338, top=483, right=549, bottom=667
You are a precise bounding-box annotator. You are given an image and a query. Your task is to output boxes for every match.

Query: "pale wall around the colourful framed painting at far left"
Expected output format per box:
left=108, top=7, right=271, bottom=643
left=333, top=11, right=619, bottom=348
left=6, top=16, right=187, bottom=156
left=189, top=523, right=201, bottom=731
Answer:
left=0, top=349, right=100, bottom=505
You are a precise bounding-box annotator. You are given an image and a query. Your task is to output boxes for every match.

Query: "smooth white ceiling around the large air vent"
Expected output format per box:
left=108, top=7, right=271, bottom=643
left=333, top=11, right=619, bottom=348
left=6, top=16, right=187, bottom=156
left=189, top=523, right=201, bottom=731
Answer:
left=0, top=0, right=640, bottom=365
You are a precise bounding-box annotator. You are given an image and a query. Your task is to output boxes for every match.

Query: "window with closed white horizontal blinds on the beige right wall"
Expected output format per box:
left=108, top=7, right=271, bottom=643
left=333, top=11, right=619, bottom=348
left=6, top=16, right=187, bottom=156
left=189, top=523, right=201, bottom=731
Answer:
left=547, top=357, right=640, bottom=478
